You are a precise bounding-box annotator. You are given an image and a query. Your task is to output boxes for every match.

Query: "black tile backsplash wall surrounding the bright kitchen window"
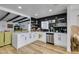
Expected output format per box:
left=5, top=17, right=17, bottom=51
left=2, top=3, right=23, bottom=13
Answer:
left=32, top=13, right=67, bottom=32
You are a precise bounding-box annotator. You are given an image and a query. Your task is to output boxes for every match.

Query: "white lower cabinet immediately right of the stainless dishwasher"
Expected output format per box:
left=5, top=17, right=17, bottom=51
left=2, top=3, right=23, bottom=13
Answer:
left=54, top=33, right=67, bottom=48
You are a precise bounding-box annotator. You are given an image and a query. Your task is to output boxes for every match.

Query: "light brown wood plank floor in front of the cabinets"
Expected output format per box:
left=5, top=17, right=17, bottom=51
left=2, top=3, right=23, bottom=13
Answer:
left=0, top=41, right=78, bottom=54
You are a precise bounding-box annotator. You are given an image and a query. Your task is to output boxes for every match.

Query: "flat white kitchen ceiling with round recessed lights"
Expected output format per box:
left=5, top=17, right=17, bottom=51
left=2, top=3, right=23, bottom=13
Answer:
left=0, top=4, right=67, bottom=19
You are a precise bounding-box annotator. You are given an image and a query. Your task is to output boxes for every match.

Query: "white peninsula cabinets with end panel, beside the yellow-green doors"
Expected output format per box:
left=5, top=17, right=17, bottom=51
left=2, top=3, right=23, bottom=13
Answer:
left=12, top=33, right=37, bottom=49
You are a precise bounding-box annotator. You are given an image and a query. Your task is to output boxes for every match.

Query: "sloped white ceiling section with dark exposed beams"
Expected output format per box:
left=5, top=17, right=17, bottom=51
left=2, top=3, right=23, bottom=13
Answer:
left=0, top=10, right=29, bottom=23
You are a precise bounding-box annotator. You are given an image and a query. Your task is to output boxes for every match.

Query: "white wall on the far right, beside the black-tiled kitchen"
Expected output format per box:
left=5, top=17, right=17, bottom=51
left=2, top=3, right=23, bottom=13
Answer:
left=67, top=5, right=79, bottom=52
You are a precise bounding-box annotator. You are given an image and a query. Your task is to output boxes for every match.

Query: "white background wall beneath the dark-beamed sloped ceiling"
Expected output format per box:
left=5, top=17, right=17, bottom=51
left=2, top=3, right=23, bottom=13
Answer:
left=0, top=21, right=31, bottom=31
